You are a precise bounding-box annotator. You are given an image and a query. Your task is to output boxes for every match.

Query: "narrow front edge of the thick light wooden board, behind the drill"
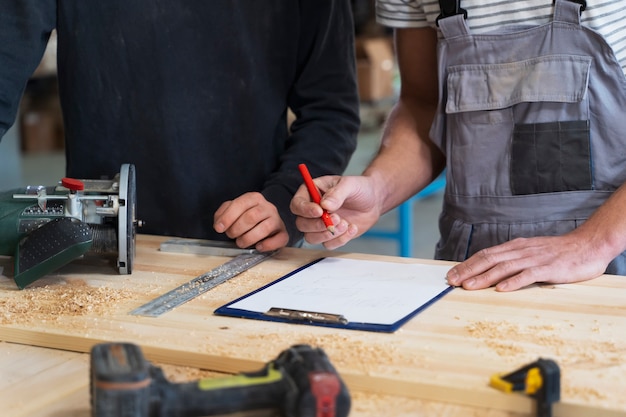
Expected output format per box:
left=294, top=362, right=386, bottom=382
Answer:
left=0, top=327, right=626, bottom=417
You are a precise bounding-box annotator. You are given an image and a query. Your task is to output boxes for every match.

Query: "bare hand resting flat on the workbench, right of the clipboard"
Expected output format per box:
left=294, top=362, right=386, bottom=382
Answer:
left=447, top=231, right=610, bottom=291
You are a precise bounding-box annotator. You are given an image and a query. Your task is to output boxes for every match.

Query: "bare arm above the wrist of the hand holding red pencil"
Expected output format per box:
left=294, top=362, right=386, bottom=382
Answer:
left=363, top=28, right=445, bottom=213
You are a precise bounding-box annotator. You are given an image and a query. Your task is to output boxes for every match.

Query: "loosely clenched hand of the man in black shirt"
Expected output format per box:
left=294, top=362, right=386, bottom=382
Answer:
left=213, top=192, right=289, bottom=252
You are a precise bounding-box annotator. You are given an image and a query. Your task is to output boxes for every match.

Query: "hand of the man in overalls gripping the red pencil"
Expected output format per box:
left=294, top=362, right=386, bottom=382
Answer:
left=289, top=175, right=380, bottom=250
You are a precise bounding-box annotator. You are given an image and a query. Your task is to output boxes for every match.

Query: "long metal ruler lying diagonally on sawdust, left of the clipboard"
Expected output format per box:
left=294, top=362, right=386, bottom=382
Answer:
left=130, top=251, right=277, bottom=317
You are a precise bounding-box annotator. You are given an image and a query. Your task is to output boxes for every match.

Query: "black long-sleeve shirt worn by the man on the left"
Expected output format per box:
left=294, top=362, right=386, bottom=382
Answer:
left=0, top=0, right=359, bottom=244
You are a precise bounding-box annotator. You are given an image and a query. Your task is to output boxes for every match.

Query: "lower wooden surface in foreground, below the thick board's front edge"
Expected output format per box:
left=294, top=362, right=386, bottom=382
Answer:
left=0, top=342, right=529, bottom=417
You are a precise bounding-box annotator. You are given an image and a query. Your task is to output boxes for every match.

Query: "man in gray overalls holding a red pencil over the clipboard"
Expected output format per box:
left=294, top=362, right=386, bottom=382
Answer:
left=291, top=0, right=626, bottom=291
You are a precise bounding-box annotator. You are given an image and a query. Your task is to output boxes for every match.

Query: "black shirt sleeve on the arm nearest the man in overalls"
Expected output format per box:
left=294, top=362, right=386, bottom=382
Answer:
left=263, top=0, right=359, bottom=234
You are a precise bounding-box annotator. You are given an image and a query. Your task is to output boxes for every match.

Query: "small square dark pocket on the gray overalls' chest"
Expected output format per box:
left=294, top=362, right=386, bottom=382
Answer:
left=511, top=120, right=593, bottom=195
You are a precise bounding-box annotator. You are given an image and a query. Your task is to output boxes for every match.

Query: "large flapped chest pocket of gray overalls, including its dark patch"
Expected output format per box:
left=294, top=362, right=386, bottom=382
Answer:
left=445, top=55, right=593, bottom=195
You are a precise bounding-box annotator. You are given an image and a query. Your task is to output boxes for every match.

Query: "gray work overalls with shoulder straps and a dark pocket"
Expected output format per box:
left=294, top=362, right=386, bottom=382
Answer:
left=430, top=0, right=626, bottom=275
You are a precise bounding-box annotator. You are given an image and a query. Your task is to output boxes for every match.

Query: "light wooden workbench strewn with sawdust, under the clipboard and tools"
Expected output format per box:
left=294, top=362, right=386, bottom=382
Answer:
left=0, top=236, right=626, bottom=417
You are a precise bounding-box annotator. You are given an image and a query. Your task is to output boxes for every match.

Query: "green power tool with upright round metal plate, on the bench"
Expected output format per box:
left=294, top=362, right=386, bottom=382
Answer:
left=0, top=164, right=141, bottom=289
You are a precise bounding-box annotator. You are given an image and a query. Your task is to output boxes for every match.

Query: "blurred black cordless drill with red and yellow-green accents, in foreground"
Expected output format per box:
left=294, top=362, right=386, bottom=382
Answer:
left=91, top=343, right=350, bottom=417
